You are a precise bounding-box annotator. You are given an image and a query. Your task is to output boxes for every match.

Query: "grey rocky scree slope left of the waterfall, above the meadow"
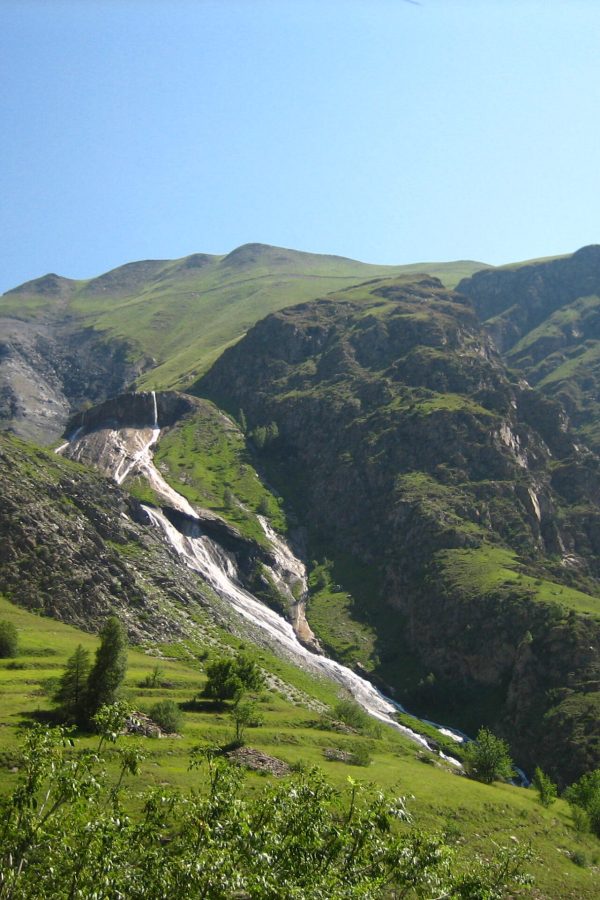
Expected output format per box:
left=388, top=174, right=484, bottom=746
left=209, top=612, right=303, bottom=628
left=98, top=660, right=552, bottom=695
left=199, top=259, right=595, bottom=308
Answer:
left=0, top=436, right=216, bottom=641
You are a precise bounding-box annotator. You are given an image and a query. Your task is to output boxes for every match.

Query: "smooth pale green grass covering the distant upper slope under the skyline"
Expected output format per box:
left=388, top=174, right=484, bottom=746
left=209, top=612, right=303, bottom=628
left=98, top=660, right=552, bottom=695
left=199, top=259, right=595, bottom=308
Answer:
left=0, top=245, right=483, bottom=389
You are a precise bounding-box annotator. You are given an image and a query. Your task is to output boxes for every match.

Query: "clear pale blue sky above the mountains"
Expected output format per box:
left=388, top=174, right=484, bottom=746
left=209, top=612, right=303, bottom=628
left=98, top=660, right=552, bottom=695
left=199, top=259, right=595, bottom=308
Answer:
left=0, top=0, right=600, bottom=290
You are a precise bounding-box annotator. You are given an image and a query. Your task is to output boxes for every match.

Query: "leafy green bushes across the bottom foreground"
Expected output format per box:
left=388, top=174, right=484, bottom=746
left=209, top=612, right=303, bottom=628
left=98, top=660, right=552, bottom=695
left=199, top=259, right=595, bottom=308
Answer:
left=0, top=707, right=527, bottom=900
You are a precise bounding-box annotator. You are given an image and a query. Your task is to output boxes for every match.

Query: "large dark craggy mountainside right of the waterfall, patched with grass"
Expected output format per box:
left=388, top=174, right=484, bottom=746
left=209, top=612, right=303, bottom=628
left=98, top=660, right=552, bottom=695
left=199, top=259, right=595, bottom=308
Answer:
left=196, top=278, right=600, bottom=780
